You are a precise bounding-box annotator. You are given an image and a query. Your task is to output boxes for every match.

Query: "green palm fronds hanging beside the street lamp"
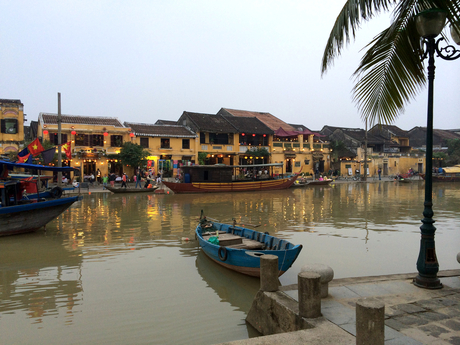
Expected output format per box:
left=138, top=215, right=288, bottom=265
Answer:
left=321, top=0, right=460, bottom=125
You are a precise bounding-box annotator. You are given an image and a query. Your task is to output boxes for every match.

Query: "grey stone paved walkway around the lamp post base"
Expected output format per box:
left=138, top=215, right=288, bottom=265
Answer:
left=219, top=270, right=460, bottom=345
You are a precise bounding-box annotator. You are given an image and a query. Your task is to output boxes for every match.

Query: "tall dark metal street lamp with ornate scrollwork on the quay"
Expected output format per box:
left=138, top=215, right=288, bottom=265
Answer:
left=414, top=9, right=460, bottom=289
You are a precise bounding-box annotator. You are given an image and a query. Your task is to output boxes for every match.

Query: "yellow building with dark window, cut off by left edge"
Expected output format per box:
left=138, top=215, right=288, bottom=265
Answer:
left=0, top=99, right=24, bottom=154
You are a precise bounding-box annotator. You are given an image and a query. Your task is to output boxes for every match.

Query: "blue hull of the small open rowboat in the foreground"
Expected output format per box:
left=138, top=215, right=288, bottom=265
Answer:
left=195, top=223, right=302, bottom=277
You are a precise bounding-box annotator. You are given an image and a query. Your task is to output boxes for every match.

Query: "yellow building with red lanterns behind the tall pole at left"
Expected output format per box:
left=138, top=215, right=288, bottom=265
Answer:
left=37, top=113, right=134, bottom=177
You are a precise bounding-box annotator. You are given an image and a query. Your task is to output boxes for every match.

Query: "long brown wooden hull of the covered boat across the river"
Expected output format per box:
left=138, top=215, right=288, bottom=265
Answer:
left=163, top=176, right=297, bottom=193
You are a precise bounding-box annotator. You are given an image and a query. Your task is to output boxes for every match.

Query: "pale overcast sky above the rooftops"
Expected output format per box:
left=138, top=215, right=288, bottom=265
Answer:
left=0, top=0, right=460, bottom=130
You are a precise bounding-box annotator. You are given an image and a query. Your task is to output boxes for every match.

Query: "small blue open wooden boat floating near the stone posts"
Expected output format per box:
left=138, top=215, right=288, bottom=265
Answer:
left=195, top=212, right=302, bottom=277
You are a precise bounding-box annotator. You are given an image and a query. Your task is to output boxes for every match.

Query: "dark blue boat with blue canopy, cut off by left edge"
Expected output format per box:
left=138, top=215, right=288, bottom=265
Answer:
left=0, top=161, right=81, bottom=236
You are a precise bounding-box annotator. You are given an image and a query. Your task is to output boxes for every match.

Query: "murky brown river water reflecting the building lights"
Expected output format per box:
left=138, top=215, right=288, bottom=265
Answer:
left=0, top=181, right=460, bottom=344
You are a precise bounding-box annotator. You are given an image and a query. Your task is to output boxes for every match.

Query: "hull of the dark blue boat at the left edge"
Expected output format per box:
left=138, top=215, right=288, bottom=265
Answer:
left=0, top=196, right=81, bottom=236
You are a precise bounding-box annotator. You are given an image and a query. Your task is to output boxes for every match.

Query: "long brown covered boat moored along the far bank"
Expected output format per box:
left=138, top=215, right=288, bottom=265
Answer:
left=163, top=163, right=298, bottom=193
